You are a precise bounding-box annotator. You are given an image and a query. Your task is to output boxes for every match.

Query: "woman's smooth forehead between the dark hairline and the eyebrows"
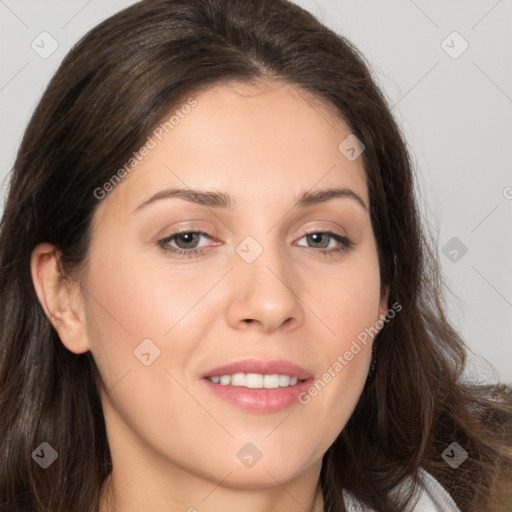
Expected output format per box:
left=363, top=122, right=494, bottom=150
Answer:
left=93, top=82, right=368, bottom=221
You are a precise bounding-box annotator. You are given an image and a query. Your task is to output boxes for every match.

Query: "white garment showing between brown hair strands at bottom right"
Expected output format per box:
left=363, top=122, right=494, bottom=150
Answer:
left=343, top=468, right=461, bottom=512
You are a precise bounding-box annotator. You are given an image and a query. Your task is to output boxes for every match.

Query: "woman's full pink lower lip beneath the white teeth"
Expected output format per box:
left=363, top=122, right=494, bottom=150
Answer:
left=203, top=379, right=313, bottom=414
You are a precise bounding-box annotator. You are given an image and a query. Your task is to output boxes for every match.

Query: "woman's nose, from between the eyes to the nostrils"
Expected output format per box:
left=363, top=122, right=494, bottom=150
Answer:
left=227, top=240, right=304, bottom=333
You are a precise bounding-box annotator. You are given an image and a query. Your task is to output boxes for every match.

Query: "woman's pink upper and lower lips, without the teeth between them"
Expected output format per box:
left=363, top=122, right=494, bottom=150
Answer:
left=201, top=359, right=314, bottom=414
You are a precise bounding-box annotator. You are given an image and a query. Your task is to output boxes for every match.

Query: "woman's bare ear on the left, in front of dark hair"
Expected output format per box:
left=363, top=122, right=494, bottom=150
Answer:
left=30, top=243, right=90, bottom=354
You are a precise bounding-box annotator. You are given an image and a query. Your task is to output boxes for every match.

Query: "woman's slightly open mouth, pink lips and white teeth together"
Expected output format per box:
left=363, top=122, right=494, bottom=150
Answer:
left=201, top=359, right=314, bottom=414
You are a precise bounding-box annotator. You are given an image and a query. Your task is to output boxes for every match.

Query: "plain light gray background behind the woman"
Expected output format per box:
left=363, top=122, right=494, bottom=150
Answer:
left=0, top=0, right=512, bottom=383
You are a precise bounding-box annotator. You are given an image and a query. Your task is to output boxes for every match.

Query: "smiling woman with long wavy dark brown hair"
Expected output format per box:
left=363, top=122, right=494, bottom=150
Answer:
left=0, top=0, right=512, bottom=512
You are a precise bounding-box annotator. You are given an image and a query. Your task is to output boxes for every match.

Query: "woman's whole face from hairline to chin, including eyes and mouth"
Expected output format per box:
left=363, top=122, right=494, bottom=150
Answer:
left=83, top=83, right=386, bottom=488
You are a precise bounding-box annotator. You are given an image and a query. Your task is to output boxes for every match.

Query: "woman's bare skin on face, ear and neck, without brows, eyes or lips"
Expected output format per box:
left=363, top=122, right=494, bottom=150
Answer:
left=32, top=82, right=387, bottom=512
